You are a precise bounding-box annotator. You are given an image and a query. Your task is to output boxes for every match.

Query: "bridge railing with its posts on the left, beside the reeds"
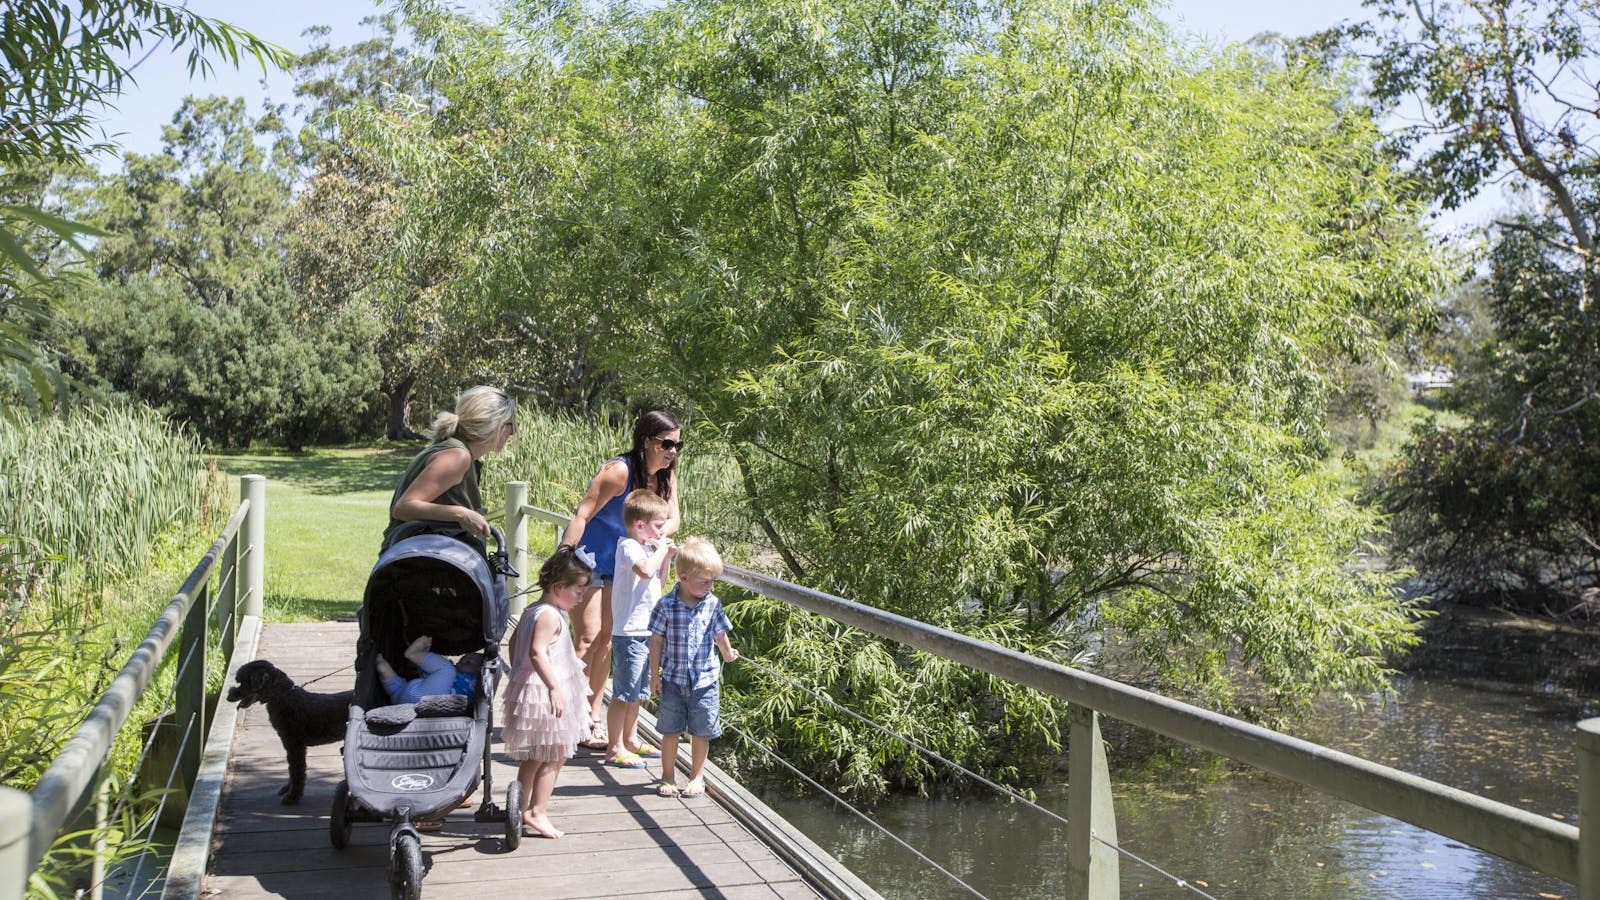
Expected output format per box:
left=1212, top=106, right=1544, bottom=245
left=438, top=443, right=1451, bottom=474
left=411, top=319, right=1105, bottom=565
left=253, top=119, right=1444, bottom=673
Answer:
left=0, top=476, right=267, bottom=900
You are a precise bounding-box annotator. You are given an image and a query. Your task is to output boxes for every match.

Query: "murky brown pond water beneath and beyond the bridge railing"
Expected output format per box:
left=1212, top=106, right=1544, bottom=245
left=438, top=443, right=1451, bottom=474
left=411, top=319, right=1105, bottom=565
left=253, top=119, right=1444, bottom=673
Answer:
left=762, top=676, right=1600, bottom=900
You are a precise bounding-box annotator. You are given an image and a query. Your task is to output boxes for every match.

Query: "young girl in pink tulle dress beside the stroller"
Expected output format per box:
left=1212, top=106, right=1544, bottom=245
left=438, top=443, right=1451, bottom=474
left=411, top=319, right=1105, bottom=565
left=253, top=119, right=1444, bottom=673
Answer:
left=501, top=548, right=594, bottom=838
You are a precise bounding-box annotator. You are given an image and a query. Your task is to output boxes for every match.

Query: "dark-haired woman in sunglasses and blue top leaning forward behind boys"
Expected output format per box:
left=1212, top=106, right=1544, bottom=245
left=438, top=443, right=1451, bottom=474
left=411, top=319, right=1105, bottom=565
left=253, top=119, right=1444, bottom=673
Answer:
left=562, top=410, right=683, bottom=749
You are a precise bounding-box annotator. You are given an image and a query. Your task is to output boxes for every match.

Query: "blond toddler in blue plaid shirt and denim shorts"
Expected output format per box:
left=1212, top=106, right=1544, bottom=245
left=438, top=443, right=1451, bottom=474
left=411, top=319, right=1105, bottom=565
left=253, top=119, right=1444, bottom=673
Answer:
left=650, top=538, right=739, bottom=798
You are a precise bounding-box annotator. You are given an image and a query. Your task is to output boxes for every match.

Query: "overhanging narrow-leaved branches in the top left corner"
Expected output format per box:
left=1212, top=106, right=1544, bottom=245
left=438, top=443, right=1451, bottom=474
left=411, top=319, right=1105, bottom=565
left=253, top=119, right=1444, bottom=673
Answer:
left=0, top=0, right=288, bottom=400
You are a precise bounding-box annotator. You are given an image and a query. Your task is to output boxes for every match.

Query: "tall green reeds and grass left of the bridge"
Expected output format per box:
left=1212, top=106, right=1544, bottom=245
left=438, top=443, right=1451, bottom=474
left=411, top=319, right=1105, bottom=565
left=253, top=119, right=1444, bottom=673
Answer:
left=0, top=407, right=226, bottom=895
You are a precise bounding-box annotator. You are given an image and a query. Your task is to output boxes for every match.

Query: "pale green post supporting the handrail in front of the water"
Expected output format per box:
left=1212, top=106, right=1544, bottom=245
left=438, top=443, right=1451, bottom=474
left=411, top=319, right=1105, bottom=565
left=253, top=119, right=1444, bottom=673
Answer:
left=1067, top=703, right=1122, bottom=900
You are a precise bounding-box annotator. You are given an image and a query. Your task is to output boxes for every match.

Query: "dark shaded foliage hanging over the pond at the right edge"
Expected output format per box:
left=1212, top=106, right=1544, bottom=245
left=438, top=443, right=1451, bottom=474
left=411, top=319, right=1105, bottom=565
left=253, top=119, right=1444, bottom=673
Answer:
left=1387, top=223, right=1600, bottom=613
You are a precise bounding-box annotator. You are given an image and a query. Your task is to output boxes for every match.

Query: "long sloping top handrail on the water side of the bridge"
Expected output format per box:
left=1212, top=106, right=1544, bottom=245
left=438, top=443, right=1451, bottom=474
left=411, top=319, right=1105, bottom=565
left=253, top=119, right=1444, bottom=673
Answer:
left=507, top=495, right=1600, bottom=900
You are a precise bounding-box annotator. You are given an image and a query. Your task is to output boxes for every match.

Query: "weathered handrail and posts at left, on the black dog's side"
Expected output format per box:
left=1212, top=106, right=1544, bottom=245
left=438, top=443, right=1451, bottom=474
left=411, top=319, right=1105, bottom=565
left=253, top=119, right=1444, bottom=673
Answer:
left=0, top=476, right=266, bottom=900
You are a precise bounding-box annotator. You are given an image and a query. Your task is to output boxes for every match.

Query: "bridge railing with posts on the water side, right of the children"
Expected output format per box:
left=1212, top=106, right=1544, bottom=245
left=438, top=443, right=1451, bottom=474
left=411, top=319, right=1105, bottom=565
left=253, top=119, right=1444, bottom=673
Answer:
left=506, top=482, right=1600, bottom=900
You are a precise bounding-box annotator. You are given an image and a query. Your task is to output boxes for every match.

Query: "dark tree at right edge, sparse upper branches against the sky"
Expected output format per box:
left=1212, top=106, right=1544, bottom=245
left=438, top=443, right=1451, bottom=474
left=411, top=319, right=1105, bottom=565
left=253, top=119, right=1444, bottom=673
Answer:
left=1344, top=0, right=1600, bottom=609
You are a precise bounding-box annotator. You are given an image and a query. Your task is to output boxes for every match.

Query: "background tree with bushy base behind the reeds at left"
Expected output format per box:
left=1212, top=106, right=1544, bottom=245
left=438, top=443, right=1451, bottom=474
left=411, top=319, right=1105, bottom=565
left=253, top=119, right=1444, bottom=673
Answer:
left=58, top=98, right=376, bottom=448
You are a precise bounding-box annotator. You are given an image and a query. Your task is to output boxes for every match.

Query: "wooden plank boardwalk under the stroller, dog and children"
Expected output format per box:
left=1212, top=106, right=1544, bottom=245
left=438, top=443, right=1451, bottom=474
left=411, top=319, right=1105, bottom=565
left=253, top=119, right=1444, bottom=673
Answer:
left=203, top=623, right=818, bottom=900
